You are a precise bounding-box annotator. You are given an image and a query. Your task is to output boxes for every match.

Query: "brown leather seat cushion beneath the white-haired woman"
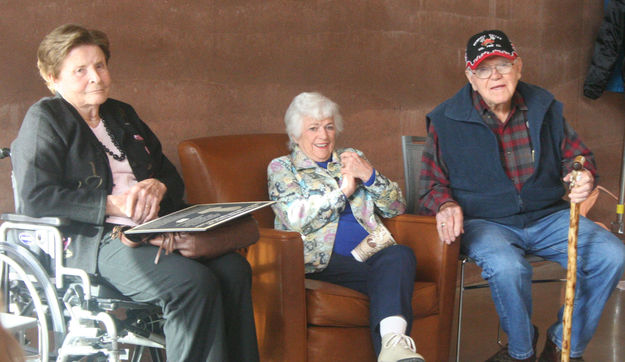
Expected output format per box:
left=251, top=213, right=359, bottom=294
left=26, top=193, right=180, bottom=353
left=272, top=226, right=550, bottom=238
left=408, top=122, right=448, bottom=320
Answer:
left=305, top=279, right=438, bottom=327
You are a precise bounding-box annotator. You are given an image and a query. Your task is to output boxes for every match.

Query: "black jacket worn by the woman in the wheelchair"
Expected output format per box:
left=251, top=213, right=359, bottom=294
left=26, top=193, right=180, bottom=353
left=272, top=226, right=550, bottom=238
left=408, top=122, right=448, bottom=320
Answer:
left=11, top=96, right=184, bottom=273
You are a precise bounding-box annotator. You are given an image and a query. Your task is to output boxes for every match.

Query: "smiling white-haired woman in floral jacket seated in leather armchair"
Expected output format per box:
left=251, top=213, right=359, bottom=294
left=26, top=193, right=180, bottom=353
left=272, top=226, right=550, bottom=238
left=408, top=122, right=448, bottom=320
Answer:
left=267, top=93, right=424, bottom=361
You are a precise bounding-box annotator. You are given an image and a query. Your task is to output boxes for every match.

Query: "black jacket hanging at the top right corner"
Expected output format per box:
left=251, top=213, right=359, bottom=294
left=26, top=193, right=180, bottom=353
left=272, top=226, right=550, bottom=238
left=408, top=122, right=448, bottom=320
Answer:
left=584, top=0, right=625, bottom=99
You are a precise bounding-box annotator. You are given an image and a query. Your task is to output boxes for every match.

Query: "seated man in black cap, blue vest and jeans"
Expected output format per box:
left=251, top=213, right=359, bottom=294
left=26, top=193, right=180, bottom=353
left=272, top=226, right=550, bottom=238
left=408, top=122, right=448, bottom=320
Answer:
left=420, top=30, right=625, bottom=361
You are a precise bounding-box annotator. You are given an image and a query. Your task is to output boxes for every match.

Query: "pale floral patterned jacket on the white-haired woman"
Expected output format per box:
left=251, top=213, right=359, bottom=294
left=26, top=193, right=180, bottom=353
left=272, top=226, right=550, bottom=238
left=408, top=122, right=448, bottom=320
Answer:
left=267, top=146, right=406, bottom=273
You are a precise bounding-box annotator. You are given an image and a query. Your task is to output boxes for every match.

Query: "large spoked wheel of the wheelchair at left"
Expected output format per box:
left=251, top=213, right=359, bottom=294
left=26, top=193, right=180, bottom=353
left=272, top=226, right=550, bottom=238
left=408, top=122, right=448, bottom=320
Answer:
left=0, top=242, right=67, bottom=361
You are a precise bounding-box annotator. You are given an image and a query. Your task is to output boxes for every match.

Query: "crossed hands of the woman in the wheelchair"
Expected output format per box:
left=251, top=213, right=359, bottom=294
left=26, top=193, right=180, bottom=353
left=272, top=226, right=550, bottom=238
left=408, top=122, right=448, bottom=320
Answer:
left=106, top=178, right=167, bottom=224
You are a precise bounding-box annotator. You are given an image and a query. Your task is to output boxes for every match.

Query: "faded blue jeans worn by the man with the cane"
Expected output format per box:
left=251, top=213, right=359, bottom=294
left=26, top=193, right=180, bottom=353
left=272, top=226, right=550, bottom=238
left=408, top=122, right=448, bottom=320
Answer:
left=462, top=210, right=625, bottom=359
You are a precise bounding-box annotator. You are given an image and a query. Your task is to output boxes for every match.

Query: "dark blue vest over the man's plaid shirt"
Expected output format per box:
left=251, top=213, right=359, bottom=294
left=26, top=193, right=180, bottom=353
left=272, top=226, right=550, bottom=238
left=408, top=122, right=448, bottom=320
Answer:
left=427, top=82, right=567, bottom=227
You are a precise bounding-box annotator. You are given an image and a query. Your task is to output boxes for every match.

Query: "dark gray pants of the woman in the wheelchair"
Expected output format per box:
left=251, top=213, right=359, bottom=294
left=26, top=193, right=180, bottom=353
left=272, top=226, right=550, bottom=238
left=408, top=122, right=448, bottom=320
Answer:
left=98, top=228, right=259, bottom=362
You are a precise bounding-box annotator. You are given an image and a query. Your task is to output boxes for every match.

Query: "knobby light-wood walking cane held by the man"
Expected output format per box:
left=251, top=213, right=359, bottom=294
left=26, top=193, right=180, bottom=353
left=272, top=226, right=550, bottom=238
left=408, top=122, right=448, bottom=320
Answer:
left=562, top=156, right=586, bottom=362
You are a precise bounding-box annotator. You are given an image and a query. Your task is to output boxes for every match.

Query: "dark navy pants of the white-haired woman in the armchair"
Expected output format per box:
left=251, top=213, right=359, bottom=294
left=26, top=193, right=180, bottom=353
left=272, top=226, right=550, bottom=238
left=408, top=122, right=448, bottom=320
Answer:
left=306, top=245, right=417, bottom=355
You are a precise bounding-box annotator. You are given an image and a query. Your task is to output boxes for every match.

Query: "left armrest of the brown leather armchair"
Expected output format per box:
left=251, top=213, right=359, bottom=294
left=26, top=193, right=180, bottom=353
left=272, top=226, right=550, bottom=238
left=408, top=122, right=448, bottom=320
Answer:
left=247, top=228, right=306, bottom=361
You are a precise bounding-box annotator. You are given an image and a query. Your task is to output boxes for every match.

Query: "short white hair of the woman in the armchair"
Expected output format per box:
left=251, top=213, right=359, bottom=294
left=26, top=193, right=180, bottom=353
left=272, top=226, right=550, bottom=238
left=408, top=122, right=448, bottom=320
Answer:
left=284, top=92, right=343, bottom=149
